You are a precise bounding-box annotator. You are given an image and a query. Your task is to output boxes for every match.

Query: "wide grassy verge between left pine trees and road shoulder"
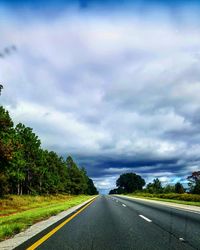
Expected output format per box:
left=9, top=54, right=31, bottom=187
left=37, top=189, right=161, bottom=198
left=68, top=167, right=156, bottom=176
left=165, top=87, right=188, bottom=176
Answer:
left=0, top=195, right=92, bottom=241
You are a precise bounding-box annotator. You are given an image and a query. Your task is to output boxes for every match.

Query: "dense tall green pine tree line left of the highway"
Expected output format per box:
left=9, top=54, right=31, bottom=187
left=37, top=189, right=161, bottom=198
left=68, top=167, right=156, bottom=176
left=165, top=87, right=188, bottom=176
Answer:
left=0, top=104, right=98, bottom=196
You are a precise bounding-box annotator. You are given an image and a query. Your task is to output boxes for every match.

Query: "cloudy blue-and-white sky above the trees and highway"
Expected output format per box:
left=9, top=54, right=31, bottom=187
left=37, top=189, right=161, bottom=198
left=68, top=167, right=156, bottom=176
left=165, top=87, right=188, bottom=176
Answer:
left=0, top=0, right=200, bottom=192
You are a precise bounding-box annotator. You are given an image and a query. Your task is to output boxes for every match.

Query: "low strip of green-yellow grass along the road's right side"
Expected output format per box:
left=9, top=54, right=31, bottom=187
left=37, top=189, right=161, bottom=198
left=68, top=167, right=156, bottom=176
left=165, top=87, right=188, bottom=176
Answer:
left=123, top=193, right=200, bottom=206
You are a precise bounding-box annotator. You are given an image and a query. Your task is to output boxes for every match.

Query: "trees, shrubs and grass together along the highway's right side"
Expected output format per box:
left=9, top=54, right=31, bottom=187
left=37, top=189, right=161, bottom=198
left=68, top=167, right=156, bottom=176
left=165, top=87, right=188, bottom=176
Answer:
left=110, top=171, right=200, bottom=206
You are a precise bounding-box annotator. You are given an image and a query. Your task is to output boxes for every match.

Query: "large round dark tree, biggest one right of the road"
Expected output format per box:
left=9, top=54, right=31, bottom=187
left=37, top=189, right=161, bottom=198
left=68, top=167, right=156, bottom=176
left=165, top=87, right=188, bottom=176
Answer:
left=116, top=173, right=145, bottom=193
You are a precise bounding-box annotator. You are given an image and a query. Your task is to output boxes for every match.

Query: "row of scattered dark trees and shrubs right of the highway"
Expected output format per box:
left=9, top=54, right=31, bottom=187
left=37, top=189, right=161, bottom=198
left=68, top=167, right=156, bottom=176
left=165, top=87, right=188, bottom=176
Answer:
left=109, top=171, right=200, bottom=194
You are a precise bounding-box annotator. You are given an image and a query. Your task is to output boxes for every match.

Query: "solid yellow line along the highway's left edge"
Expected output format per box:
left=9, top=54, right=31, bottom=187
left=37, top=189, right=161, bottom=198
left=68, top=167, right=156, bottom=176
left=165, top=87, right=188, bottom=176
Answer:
left=27, top=197, right=96, bottom=250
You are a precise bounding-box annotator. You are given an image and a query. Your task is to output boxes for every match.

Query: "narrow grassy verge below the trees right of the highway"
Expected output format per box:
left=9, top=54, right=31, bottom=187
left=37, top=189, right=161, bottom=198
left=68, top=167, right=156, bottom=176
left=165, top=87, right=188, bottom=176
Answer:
left=122, top=193, right=200, bottom=207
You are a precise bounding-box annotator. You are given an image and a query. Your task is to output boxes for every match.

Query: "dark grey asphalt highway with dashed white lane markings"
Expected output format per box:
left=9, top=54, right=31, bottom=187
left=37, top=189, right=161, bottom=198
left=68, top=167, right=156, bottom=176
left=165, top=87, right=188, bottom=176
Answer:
left=16, top=196, right=200, bottom=250
